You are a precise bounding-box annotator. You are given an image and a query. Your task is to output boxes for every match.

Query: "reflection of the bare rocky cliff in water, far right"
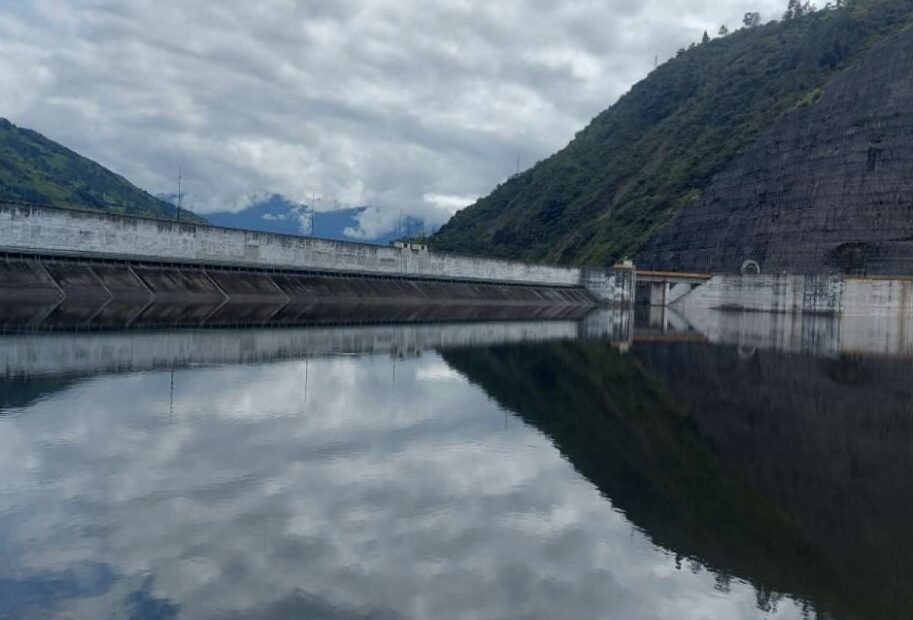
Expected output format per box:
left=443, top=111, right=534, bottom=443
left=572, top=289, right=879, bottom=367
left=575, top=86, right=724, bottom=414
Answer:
left=636, top=346, right=913, bottom=618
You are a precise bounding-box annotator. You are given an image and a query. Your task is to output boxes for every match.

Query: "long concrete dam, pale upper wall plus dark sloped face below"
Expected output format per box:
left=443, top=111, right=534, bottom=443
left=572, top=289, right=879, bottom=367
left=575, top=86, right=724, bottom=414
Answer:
left=0, top=203, right=634, bottom=305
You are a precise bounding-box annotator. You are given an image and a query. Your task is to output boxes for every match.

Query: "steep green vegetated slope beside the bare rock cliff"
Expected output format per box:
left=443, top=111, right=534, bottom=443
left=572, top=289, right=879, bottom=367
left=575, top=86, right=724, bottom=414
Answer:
left=432, top=0, right=913, bottom=264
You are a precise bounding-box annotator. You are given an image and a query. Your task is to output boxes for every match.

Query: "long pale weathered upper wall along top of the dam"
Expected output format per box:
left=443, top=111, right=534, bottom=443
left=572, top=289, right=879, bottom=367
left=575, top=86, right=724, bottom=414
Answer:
left=0, top=204, right=581, bottom=286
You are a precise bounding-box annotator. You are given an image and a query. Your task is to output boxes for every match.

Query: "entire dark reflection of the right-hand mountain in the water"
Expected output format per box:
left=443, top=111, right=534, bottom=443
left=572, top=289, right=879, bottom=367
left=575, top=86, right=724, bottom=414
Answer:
left=444, top=342, right=913, bottom=619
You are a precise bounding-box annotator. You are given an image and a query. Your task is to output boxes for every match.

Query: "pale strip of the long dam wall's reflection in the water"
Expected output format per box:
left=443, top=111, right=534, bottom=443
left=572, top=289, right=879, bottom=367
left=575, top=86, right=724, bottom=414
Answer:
left=0, top=309, right=632, bottom=377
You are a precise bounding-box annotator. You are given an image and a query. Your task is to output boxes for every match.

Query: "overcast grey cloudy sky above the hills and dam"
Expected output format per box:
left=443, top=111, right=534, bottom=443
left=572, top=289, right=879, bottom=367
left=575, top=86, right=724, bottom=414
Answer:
left=0, top=0, right=786, bottom=236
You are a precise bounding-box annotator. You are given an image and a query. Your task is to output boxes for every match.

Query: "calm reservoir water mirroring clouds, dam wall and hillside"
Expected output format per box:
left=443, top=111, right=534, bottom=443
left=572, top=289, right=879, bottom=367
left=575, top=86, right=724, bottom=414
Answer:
left=0, top=311, right=913, bottom=620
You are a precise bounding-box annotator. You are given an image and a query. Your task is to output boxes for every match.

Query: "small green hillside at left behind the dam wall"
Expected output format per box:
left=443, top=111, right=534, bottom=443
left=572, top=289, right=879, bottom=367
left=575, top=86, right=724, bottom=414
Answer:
left=0, top=118, right=204, bottom=222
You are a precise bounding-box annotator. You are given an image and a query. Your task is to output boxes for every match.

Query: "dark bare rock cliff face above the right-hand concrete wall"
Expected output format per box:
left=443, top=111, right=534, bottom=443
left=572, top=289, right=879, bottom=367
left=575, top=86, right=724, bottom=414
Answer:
left=637, top=30, right=913, bottom=274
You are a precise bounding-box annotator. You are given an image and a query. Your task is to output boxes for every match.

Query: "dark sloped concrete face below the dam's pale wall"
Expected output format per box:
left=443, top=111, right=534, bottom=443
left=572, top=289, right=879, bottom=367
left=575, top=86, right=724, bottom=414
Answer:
left=0, top=259, right=599, bottom=306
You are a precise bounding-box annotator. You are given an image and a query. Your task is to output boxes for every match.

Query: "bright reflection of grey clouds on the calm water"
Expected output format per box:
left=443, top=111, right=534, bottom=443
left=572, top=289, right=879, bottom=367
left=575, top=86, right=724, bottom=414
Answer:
left=0, top=353, right=801, bottom=620
